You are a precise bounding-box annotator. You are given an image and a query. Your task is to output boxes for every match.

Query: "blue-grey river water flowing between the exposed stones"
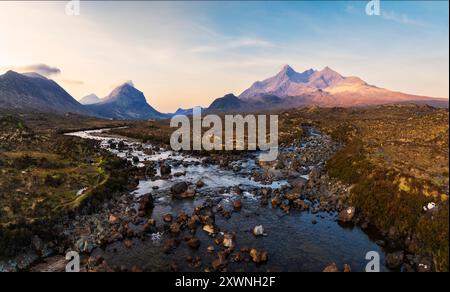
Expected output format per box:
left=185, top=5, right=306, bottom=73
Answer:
left=68, top=129, right=389, bottom=272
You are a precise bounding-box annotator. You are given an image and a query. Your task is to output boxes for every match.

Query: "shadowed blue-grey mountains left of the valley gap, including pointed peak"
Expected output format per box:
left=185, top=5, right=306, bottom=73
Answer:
left=0, top=71, right=167, bottom=120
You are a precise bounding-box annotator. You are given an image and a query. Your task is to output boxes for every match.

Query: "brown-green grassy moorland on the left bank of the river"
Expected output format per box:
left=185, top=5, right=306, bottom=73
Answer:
left=0, top=116, right=127, bottom=255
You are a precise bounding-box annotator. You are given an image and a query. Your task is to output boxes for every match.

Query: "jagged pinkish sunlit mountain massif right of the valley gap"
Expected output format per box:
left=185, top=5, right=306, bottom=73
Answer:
left=209, top=65, right=448, bottom=112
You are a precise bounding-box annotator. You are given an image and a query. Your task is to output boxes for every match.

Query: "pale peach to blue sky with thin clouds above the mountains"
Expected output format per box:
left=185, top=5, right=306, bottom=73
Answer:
left=0, top=0, right=449, bottom=112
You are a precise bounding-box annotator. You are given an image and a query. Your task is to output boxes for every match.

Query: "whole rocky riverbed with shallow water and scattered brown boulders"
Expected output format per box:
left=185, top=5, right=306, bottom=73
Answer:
left=3, top=128, right=398, bottom=271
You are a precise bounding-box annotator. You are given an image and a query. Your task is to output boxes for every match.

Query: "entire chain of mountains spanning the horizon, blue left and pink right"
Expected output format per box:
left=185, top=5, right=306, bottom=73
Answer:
left=0, top=65, right=449, bottom=120
